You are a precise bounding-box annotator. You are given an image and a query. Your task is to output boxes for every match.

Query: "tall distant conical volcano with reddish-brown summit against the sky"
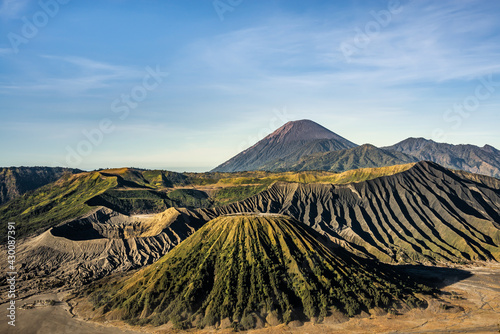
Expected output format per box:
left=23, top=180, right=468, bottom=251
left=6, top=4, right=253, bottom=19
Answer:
left=212, top=120, right=356, bottom=172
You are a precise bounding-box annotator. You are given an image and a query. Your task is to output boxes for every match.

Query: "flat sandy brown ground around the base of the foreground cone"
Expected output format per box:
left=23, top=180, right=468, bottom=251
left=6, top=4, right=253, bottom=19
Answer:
left=0, top=263, right=500, bottom=334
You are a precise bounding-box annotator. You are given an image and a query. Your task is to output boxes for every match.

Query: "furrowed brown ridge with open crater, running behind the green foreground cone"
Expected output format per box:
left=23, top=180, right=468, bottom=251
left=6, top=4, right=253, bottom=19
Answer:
left=4, top=162, right=500, bottom=302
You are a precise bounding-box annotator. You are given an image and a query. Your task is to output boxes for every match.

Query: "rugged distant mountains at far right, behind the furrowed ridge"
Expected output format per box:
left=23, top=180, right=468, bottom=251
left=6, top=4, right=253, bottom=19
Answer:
left=385, top=138, right=500, bottom=178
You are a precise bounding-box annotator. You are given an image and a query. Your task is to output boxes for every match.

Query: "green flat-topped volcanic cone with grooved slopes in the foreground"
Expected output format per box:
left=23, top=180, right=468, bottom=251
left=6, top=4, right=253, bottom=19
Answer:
left=85, top=214, right=426, bottom=329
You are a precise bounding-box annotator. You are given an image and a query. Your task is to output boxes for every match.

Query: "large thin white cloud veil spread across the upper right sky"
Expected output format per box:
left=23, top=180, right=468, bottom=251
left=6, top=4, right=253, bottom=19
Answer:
left=186, top=2, right=500, bottom=90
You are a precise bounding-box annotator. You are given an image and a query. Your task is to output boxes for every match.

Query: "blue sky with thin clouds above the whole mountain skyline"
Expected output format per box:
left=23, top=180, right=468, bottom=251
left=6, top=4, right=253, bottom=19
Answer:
left=0, top=0, right=500, bottom=171
